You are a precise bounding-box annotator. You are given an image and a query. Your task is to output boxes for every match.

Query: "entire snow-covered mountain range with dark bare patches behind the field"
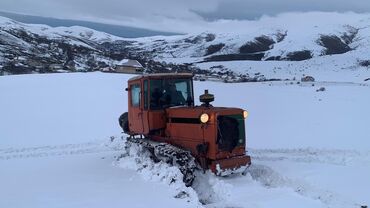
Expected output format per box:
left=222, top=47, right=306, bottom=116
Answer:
left=0, top=12, right=370, bottom=81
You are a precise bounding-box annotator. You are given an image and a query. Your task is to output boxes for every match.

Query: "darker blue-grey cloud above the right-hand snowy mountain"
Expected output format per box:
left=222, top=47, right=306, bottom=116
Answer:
left=197, top=0, right=370, bottom=20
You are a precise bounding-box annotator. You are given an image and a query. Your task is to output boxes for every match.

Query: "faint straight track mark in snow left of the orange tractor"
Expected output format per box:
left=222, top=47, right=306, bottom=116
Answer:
left=0, top=137, right=121, bottom=160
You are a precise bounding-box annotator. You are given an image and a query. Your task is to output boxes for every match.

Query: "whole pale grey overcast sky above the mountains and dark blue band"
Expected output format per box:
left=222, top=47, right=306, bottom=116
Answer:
left=0, top=0, right=370, bottom=32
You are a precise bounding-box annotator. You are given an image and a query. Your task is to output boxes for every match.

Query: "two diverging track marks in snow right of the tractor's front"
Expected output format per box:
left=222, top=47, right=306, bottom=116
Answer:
left=247, top=148, right=370, bottom=208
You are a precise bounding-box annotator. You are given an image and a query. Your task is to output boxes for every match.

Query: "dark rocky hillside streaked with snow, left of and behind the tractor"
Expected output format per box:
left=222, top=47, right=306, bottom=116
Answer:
left=0, top=17, right=199, bottom=75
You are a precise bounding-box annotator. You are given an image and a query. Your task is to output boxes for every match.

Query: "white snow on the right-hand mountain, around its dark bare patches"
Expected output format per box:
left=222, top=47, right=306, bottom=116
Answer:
left=133, top=12, right=370, bottom=69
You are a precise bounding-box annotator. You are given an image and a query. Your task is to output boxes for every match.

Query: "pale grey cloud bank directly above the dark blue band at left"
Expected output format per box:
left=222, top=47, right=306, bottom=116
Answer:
left=0, top=0, right=223, bottom=32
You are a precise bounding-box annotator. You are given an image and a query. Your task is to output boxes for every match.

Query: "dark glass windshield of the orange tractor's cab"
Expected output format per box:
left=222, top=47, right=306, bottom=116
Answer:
left=150, top=79, right=194, bottom=110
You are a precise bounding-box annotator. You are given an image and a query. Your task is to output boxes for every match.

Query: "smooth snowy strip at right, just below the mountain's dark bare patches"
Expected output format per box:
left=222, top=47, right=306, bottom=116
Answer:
left=197, top=57, right=370, bottom=85
